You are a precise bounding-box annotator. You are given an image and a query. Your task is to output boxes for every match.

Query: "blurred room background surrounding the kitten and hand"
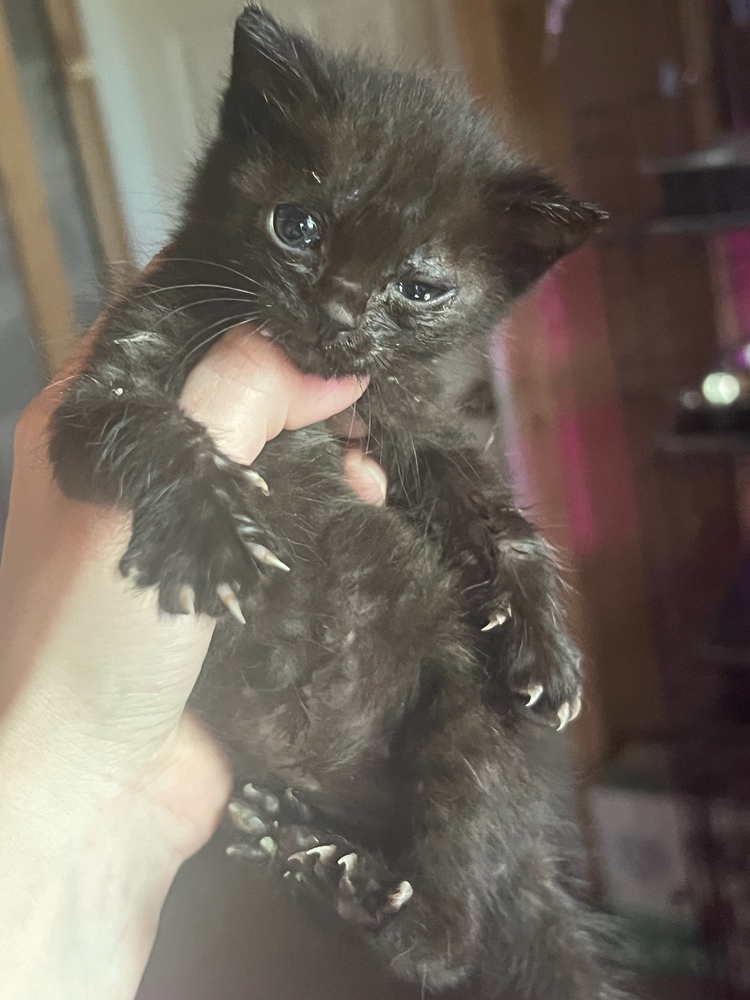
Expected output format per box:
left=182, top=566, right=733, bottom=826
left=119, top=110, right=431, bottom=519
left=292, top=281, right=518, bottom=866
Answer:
left=0, top=0, right=750, bottom=1000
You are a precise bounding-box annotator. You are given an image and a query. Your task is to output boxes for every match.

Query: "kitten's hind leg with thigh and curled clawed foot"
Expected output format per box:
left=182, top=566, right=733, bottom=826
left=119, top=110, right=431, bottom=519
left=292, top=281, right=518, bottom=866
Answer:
left=223, top=724, right=620, bottom=1000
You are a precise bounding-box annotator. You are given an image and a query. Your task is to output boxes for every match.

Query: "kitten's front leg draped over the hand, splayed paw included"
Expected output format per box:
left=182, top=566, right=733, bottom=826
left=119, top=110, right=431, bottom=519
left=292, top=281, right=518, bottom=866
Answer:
left=50, top=290, right=286, bottom=619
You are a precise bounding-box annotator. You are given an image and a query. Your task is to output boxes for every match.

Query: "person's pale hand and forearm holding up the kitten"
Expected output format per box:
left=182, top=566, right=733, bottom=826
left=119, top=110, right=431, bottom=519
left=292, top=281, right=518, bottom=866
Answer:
left=0, top=328, right=386, bottom=1000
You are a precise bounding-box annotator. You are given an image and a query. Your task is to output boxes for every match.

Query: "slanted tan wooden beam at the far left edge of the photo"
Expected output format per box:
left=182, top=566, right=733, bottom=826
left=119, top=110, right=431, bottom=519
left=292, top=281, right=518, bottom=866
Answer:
left=0, top=4, right=76, bottom=372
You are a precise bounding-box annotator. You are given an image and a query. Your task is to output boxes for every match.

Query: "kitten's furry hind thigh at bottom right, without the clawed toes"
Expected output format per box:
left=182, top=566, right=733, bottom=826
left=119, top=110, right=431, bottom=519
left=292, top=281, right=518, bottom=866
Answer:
left=373, top=696, right=616, bottom=1000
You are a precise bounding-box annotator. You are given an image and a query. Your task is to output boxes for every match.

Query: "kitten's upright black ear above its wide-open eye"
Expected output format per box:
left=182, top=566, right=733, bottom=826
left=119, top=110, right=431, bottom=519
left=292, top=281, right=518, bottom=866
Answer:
left=221, top=4, right=334, bottom=145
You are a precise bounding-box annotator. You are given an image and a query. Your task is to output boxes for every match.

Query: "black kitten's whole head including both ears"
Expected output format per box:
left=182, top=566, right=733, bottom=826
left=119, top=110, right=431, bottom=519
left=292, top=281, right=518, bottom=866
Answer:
left=188, top=7, right=596, bottom=377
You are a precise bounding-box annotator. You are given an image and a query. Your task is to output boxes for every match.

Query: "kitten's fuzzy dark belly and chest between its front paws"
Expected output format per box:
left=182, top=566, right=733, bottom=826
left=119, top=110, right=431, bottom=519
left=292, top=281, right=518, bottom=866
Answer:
left=196, top=434, right=460, bottom=825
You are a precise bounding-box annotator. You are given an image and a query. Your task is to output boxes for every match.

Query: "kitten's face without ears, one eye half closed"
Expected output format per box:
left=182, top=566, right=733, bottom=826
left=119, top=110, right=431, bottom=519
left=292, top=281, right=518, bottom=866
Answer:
left=220, top=122, right=500, bottom=375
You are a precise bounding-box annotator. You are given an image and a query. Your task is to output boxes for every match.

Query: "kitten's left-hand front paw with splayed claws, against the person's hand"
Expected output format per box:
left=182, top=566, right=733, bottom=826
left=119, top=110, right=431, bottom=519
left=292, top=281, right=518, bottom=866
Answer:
left=120, top=462, right=289, bottom=624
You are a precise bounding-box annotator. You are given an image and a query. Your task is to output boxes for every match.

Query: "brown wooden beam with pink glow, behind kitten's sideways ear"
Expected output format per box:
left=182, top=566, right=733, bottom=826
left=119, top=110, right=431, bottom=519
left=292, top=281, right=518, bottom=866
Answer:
left=454, top=0, right=661, bottom=773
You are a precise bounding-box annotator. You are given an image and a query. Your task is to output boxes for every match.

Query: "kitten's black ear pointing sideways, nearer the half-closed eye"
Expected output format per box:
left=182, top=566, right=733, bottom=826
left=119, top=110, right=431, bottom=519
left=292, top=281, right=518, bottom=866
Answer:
left=490, top=168, right=609, bottom=294
